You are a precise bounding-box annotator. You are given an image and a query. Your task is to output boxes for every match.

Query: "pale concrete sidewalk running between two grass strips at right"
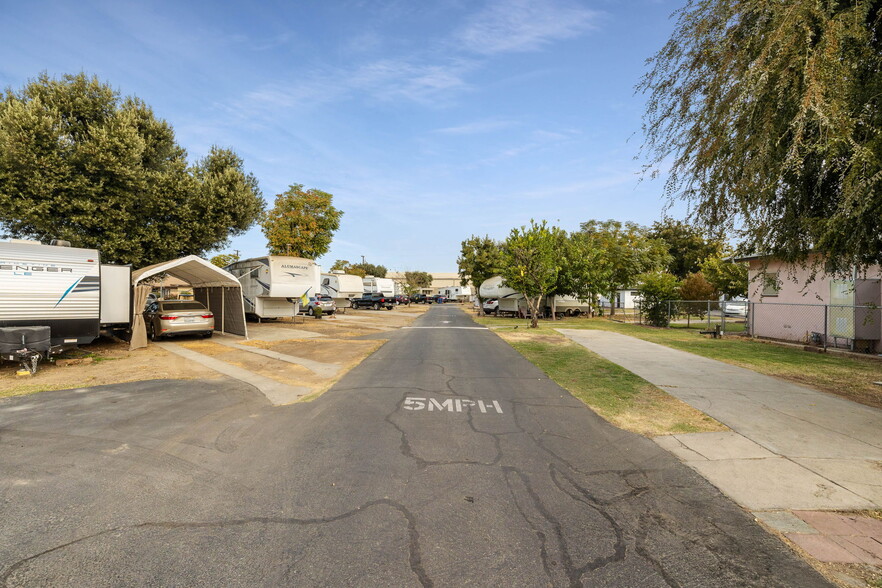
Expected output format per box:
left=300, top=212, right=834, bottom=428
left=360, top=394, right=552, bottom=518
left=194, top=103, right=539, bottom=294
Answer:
left=557, top=329, right=882, bottom=511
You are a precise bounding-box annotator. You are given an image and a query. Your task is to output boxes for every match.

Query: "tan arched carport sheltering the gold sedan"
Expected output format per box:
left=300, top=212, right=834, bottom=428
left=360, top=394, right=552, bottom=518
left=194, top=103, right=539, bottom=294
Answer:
left=132, top=255, right=248, bottom=349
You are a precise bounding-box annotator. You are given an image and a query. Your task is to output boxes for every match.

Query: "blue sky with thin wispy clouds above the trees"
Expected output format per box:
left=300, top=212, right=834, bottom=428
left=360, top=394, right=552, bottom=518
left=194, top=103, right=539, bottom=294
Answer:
left=0, top=0, right=684, bottom=271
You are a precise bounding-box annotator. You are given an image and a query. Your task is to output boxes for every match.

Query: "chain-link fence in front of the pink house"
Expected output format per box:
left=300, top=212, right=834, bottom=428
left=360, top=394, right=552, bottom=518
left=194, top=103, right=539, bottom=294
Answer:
left=628, top=300, right=882, bottom=353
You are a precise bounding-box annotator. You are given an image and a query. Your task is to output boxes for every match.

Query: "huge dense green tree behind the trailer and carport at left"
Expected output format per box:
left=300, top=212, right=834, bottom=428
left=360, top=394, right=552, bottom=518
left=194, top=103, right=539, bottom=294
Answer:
left=0, top=73, right=263, bottom=267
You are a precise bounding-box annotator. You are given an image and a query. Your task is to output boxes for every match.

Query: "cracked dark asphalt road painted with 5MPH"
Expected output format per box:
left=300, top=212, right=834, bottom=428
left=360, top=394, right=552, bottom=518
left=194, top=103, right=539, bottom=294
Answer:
left=0, top=306, right=827, bottom=588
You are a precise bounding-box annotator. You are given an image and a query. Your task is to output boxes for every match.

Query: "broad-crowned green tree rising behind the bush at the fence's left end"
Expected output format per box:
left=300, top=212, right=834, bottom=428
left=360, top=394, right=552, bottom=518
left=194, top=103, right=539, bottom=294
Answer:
left=581, top=220, right=670, bottom=316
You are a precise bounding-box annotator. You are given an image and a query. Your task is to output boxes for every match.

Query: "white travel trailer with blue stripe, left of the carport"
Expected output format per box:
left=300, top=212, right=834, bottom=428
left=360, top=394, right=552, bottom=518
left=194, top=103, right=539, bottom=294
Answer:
left=0, top=240, right=132, bottom=372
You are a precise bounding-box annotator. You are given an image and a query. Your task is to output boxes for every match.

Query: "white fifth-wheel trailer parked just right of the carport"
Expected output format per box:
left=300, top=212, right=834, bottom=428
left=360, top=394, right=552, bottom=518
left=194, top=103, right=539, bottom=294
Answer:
left=224, top=255, right=321, bottom=319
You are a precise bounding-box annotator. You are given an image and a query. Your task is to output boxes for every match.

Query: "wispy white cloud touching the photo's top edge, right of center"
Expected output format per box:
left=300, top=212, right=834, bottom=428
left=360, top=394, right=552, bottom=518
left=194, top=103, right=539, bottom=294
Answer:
left=456, top=0, right=601, bottom=55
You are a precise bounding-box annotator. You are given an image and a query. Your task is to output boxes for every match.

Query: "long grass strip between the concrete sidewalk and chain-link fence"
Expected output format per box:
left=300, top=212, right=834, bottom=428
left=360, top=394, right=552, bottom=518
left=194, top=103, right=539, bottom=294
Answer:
left=475, top=317, right=882, bottom=408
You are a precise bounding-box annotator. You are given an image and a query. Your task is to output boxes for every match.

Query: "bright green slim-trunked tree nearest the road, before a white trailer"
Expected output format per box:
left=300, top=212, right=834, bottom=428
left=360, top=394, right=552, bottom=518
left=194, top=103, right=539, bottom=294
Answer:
left=501, top=220, right=560, bottom=329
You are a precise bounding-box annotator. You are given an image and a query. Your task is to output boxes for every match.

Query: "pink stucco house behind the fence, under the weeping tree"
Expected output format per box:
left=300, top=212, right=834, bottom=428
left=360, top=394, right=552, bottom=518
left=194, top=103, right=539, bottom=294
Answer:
left=736, top=256, right=882, bottom=353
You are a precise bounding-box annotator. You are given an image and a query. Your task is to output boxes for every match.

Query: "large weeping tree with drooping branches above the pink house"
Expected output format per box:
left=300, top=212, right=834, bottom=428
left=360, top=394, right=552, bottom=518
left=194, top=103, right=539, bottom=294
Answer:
left=638, top=0, right=882, bottom=272
